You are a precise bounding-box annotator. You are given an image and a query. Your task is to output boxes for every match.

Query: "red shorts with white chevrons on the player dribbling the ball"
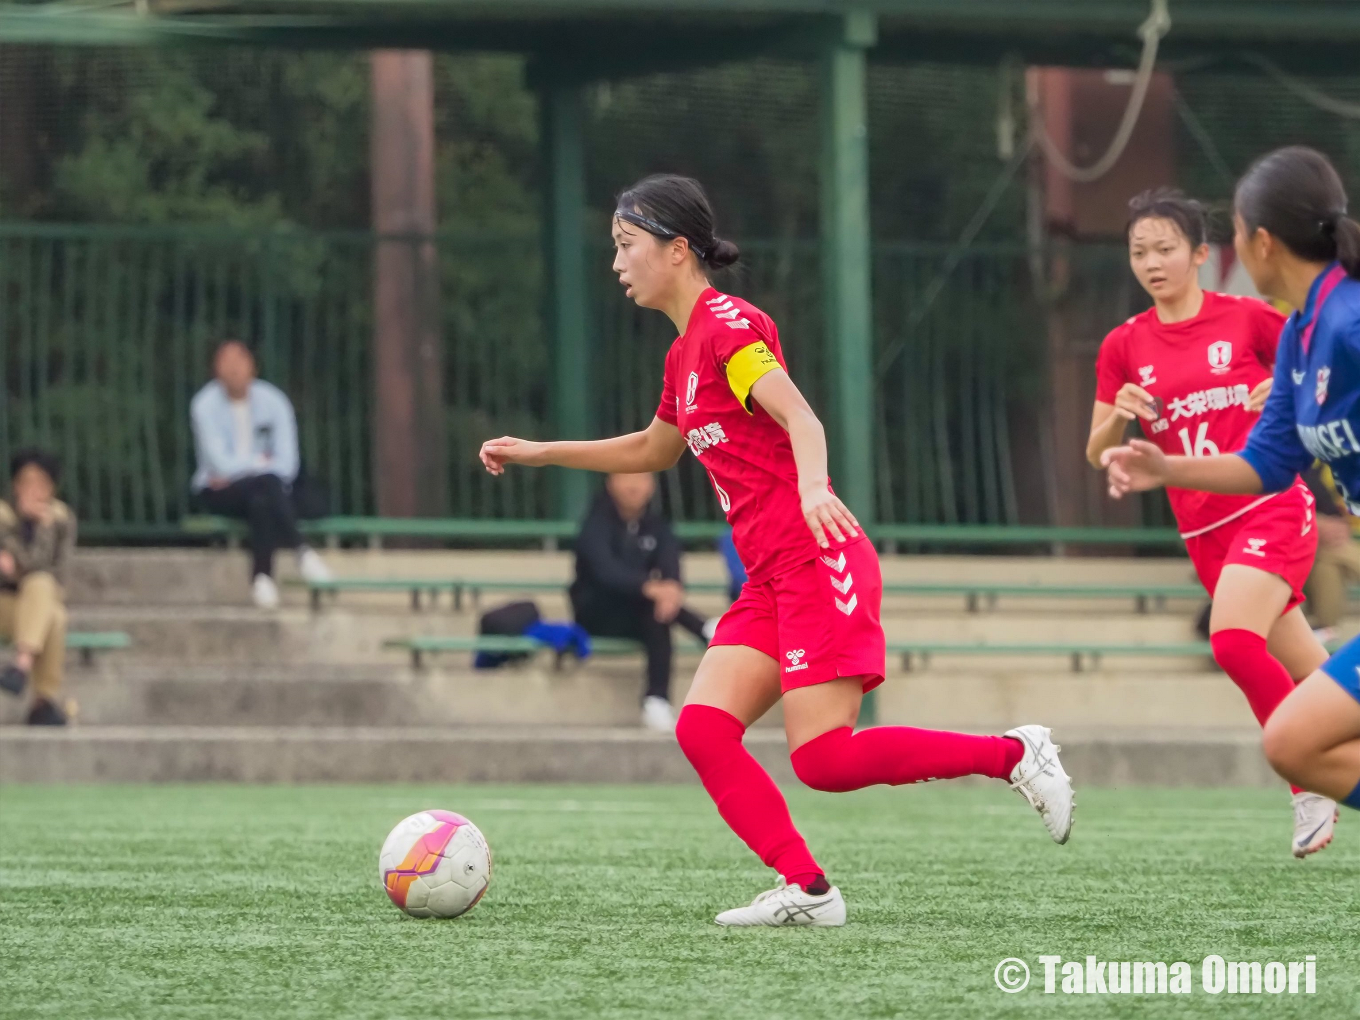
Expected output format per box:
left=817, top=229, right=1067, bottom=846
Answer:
left=710, top=539, right=888, bottom=691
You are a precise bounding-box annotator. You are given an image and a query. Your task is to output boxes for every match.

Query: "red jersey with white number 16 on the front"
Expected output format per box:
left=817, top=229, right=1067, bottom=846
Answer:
left=1096, top=291, right=1284, bottom=539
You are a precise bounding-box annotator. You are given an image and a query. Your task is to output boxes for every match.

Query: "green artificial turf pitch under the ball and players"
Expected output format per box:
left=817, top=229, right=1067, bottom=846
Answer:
left=0, top=783, right=1360, bottom=1020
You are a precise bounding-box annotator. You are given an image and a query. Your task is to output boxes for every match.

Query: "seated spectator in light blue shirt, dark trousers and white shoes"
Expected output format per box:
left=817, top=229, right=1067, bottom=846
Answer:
left=190, top=340, right=330, bottom=609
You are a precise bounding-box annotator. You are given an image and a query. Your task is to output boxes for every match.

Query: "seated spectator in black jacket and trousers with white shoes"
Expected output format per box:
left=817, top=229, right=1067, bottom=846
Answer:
left=571, top=475, right=706, bottom=733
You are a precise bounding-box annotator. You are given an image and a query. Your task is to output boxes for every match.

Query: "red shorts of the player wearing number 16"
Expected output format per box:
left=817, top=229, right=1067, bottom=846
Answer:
left=1186, top=483, right=1318, bottom=612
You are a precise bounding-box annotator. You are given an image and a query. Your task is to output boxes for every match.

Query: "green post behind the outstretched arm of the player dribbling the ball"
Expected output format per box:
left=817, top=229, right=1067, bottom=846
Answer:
left=540, top=80, right=594, bottom=520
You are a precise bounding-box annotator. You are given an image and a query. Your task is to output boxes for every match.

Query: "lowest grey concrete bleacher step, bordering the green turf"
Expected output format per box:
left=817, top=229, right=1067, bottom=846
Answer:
left=0, top=726, right=1284, bottom=788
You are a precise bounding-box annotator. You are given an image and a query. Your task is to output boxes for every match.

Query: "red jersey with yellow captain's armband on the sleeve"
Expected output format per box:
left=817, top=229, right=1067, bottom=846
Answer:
left=657, top=287, right=835, bottom=585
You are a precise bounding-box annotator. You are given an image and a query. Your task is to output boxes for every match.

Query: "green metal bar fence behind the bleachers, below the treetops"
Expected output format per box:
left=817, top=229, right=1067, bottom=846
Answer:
left=0, top=223, right=1127, bottom=528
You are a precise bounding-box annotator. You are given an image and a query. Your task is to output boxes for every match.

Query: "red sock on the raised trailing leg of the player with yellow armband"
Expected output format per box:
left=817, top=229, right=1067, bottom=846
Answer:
left=793, top=726, right=1024, bottom=793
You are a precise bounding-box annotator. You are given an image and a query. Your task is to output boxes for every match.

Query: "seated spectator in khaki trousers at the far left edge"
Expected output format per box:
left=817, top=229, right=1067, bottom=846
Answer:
left=0, top=450, right=76, bottom=726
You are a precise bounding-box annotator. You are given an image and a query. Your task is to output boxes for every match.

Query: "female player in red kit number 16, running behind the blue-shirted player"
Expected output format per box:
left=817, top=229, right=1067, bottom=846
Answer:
left=1087, top=189, right=1337, bottom=857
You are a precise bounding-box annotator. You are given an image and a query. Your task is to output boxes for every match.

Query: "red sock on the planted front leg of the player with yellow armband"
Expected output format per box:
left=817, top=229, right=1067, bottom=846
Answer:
left=676, top=704, right=821, bottom=884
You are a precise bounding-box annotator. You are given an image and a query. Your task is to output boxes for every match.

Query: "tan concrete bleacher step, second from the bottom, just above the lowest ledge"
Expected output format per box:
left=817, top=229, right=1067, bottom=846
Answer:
left=0, top=656, right=1254, bottom=732
